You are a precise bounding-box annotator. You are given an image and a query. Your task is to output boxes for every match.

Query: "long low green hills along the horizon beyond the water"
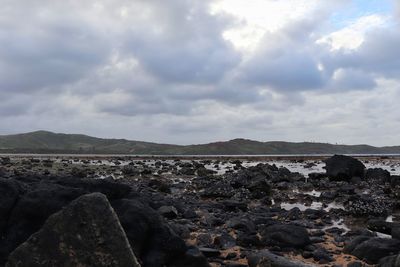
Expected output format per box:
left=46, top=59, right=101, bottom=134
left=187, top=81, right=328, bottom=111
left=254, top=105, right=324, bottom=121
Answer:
left=0, top=131, right=400, bottom=155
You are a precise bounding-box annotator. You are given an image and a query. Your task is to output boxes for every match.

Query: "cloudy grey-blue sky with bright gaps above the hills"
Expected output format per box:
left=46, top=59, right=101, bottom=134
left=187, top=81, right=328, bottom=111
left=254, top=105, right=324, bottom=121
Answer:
left=0, top=0, right=400, bottom=146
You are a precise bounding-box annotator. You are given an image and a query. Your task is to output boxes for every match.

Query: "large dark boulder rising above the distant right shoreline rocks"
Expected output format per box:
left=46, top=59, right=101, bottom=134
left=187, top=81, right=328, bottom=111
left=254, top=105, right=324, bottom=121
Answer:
left=325, top=155, right=365, bottom=181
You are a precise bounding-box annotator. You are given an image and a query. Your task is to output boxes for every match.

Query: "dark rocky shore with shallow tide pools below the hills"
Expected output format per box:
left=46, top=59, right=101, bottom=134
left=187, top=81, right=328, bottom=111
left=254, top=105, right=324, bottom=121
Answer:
left=0, top=156, right=400, bottom=267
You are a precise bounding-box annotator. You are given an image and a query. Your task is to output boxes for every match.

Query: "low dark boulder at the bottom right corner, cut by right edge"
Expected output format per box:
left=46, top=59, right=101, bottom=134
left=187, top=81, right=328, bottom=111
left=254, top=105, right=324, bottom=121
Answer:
left=345, top=236, right=400, bottom=264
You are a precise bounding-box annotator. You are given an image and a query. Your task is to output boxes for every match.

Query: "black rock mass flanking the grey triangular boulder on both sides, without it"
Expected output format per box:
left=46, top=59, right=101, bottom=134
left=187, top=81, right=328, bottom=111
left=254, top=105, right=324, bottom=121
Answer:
left=0, top=176, right=208, bottom=267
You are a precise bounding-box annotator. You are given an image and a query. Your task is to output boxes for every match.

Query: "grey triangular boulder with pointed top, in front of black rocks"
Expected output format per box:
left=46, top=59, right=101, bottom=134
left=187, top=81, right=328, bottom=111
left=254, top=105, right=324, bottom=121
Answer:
left=6, top=193, right=140, bottom=267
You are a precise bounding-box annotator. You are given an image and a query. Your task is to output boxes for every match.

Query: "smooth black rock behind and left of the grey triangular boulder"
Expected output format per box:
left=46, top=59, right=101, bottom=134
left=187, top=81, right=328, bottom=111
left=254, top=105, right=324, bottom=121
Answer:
left=0, top=176, right=131, bottom=264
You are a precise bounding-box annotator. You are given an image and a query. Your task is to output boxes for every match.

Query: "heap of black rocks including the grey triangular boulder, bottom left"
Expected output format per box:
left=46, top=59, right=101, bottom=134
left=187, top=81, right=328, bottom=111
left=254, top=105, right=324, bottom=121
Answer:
left=0, top=176, right=208, bottom=266
